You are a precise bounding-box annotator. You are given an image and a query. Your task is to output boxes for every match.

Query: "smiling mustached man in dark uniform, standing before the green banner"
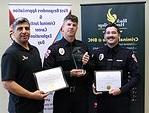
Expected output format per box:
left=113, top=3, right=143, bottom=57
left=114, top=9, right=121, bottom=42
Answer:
left=89, top=24, right=140, bottom=113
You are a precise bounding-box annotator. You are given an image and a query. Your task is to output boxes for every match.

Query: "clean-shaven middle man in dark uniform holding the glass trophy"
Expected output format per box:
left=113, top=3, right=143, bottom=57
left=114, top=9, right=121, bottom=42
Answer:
left=43, top=14, right=89, bottom=113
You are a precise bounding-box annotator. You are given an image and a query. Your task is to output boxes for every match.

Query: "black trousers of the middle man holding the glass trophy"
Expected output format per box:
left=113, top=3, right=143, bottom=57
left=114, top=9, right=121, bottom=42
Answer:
left=53, top=87, right=88, bottom=113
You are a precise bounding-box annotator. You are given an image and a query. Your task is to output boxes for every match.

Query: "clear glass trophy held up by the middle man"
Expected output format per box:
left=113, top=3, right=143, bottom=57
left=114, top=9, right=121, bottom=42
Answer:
left=72, top=47, right=85, bottom=69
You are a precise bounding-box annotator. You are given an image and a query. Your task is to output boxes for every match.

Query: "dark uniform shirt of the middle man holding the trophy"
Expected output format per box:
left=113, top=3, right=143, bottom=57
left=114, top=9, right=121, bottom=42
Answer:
left=43, top=38, right=88, bottom=86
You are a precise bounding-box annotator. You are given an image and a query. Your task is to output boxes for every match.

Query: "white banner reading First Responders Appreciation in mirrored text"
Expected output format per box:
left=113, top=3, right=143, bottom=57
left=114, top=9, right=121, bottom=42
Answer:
left=9, top=3, right=71, bottom=113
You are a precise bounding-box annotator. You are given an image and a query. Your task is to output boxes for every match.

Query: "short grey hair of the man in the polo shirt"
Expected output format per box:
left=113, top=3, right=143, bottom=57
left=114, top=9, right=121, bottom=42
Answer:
left=12, top=17, right=30, bottom=29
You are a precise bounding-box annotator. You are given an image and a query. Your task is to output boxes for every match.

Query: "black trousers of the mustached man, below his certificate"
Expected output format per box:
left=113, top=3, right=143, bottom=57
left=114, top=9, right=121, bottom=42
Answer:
left=97, top=94, right=130, bottom=113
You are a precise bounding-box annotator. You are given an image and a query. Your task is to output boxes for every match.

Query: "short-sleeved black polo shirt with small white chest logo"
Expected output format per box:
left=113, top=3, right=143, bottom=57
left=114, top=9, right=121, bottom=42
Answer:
left=1, top=42, right=43, bottom=113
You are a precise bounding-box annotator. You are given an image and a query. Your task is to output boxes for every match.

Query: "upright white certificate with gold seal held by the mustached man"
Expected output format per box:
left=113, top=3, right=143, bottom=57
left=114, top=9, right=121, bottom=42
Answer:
left=95, top=70, right=122, bottom=92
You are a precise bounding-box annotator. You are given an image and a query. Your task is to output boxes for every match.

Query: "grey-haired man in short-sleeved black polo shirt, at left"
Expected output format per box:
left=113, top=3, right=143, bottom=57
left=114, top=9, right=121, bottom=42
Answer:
left=1, top=17, right=47, bottom=113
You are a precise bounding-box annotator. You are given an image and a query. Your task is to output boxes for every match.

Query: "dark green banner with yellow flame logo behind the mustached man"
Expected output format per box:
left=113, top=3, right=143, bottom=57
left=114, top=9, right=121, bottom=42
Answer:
left=81, top=2, right=145, bottom=113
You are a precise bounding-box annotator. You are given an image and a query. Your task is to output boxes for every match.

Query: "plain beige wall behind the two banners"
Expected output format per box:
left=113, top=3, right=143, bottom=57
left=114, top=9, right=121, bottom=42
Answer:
left=0, top=0, right=149, bottom=113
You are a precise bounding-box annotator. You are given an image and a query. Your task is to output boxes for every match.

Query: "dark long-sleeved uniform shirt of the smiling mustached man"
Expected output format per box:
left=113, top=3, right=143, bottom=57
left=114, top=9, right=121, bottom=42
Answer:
left=93, top=44, right=139, bottom=93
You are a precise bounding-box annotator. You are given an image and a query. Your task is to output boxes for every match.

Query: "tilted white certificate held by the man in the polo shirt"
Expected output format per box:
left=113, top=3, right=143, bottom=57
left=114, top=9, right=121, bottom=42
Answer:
left=34, top=67, right=68, bottom=93
